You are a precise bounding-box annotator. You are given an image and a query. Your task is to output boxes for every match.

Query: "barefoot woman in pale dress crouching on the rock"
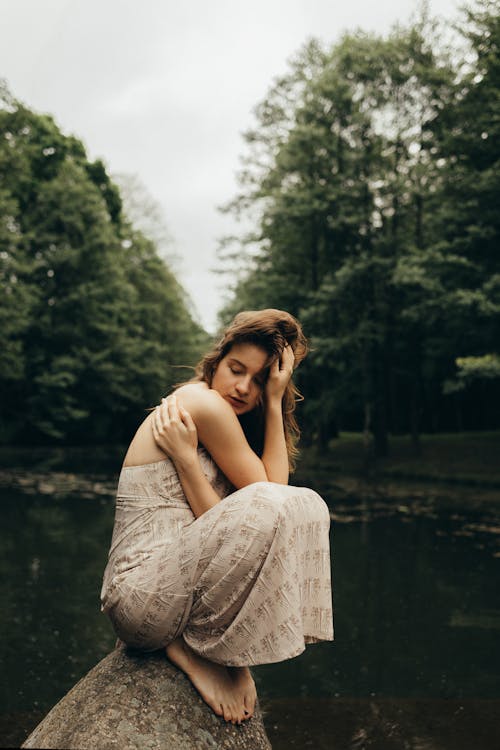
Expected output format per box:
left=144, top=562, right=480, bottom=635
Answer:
left=101, top=310, right=333, bottom=723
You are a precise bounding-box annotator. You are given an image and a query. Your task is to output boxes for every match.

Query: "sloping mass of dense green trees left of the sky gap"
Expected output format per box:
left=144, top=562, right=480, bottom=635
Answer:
left=0, top=86, right=203, bottom=443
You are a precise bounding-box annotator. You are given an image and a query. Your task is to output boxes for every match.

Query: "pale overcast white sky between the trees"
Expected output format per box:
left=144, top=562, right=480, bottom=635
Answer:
left=0, top=0, right=459, bottom=330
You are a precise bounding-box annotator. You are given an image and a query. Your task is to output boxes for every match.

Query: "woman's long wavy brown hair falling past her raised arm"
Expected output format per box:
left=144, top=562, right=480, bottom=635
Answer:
left=182, top=308, right=308, bottom=471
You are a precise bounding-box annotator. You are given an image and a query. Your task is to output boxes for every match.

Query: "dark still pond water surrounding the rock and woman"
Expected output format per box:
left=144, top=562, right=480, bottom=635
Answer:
left=0, top=452, right=500, bottom=750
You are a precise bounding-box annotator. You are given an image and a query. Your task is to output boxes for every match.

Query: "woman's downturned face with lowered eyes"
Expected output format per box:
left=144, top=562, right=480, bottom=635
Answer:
left=211, top=344, right=267, bottom=414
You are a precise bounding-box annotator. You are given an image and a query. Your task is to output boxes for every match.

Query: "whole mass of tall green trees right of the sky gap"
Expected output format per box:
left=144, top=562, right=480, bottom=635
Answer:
left=221, top=2, right=500, bottom=454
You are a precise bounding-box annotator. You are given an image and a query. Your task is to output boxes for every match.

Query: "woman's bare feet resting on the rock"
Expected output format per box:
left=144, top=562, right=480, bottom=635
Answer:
left=165, top=637, right=255, bottom=724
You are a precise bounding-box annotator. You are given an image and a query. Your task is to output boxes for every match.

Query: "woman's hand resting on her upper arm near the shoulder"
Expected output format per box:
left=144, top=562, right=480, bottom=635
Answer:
left=152, top=393, right=198, bottom=464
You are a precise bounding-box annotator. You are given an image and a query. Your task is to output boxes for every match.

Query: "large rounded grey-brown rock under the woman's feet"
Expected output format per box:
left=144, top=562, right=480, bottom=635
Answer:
left=22, top=648, right=271, bottom=750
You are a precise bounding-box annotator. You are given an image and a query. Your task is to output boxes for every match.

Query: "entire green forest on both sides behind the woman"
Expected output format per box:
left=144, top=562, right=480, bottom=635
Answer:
left=0, top=0, right=500, bottom=455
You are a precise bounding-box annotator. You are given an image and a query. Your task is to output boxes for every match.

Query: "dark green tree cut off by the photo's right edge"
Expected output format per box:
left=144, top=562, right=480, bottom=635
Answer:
left=435, top=0, right=500, bottom=412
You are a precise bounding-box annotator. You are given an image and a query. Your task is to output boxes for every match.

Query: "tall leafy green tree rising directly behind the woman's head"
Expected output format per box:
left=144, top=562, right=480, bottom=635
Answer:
left=217, top=16, right=458, bottom=454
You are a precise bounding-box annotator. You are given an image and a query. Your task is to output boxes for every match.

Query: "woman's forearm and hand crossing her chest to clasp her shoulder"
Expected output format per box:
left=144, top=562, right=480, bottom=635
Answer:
left=152, top=394, right=220, bottom=518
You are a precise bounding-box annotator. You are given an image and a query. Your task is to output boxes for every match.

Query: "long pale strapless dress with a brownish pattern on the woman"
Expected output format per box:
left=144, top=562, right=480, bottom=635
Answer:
left=101, top=448, right=333, bottom=666
